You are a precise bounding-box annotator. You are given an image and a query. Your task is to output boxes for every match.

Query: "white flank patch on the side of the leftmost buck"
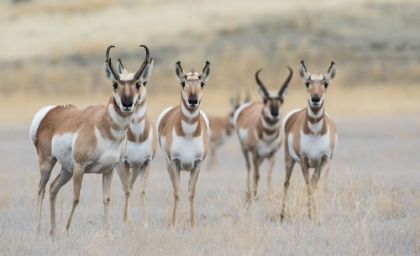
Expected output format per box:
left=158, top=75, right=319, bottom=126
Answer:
left=51, top=133, right=77, bottom=172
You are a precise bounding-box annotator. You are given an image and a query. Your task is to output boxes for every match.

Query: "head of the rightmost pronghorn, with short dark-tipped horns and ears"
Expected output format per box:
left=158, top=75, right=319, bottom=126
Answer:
left=299, top=60, right=335, bottom=108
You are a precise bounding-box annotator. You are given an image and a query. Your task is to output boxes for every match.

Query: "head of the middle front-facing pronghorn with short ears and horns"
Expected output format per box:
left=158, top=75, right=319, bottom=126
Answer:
left=175, top=61, right=211, bottom=109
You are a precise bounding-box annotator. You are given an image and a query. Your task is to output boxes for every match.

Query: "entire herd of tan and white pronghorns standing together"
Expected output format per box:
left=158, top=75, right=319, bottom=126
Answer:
left=29, top=45, right=337, bottom=235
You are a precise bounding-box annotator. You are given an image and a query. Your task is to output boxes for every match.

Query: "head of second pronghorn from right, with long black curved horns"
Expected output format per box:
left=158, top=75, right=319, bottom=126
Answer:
left=255, top=67, right=293, bottom=120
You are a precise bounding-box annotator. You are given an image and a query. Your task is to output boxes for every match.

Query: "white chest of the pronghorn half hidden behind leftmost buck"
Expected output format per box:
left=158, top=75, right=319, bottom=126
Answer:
left=122, top=129, right=153, bottom=167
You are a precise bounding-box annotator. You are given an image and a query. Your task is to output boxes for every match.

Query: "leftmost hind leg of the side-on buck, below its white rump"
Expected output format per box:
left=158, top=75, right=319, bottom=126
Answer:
left=35, top=156, right=57, bottom=233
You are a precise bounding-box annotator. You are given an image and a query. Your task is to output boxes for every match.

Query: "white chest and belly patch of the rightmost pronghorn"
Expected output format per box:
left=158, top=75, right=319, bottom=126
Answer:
left=300, top=131, right=332, bottom=168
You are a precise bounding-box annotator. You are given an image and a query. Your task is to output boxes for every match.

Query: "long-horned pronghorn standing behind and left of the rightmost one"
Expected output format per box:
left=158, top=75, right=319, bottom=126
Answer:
left=233, top=67, right=293, bottom=201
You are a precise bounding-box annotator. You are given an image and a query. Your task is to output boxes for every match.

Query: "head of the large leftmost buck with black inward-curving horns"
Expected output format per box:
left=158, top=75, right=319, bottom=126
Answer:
left=105, top=45, right=153, bottom=112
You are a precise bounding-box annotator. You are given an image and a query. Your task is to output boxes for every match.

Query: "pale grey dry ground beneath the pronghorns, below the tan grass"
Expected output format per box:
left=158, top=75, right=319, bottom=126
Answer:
left=0, top=115, right=420, bottom=255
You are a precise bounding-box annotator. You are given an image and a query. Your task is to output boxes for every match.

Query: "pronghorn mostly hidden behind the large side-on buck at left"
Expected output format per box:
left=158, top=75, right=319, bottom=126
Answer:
left=115, top=59, right=156, bottom=227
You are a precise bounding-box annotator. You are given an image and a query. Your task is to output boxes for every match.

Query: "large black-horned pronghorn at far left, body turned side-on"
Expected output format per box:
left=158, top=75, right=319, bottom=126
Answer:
left=29, top=45, right=152, bottom=235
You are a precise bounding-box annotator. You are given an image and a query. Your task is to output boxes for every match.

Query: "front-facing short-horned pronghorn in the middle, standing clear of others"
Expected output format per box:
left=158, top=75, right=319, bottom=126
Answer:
left=157, top=61, right=211, bottom=228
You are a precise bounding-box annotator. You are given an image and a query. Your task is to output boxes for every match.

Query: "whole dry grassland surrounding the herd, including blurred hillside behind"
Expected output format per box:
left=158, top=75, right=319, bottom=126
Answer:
left=0, top=0, right=420, bottom=255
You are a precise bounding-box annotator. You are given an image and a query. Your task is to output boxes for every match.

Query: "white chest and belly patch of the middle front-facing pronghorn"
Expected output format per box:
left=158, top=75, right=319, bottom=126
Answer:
left=171, top=131, right=204, bottom=171
